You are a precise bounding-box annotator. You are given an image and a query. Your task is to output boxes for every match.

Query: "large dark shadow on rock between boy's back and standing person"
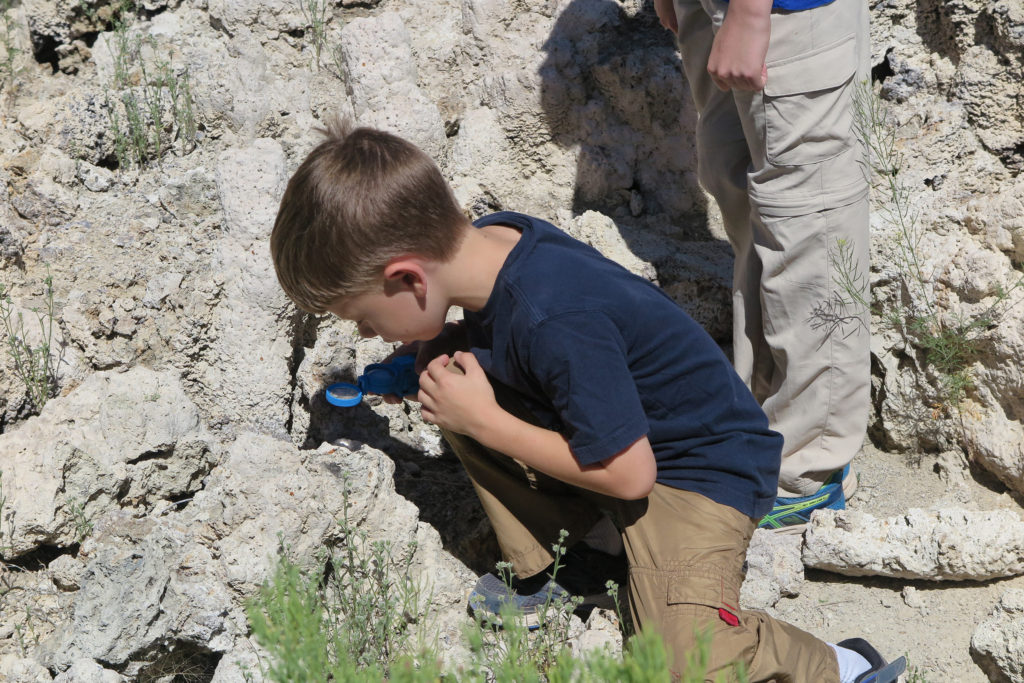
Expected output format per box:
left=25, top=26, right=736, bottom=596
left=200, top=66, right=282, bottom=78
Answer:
left=540, top=0, right=732, bottom=345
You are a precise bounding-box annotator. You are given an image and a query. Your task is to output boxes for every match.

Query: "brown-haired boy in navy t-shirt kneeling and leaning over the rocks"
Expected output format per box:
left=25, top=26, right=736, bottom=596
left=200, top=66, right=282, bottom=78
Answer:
left=270, top=124, right=896, bottom=683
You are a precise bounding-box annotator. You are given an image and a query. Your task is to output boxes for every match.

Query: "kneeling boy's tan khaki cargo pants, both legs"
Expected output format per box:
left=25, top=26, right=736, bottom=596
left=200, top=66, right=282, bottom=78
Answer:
left=443, top=385, right=839, bottom=683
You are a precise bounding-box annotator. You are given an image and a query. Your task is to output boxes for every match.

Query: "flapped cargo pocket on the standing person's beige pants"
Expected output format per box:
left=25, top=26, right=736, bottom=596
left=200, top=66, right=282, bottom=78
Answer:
left=762, top=34, right=857, bottom=166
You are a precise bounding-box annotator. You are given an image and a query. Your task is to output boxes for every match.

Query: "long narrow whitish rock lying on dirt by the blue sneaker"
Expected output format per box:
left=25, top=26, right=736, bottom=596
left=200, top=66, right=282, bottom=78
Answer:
left=803, top=509, right=1024, bottom=581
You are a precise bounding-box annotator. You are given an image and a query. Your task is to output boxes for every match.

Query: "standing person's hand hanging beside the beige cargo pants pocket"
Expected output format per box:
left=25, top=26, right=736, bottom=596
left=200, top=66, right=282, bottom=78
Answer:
left=708, top=0, right=772, bottom=91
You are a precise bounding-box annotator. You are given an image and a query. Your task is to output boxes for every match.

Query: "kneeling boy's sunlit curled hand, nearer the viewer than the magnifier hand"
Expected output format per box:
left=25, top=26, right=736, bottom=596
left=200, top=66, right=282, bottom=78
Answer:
left=418, top=351, right=501, bottom=438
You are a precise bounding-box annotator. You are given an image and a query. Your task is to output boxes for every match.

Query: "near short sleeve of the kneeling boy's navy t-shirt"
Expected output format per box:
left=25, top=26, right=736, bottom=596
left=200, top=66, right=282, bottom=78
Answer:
left=528, top=311, right=649, bottom=465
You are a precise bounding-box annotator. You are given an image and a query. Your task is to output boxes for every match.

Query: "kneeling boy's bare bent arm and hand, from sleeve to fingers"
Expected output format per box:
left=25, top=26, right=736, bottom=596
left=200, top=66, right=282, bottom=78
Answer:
left=419, top=351, right=657, bottom=500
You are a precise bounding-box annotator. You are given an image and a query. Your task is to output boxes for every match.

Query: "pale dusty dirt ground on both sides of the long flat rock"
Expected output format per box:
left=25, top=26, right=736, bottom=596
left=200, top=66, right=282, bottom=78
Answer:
left=775, top=444, right=1024, bottom=683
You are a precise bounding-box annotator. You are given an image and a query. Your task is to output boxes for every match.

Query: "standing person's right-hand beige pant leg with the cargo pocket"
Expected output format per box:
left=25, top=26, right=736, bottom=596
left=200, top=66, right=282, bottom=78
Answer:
left=733, top=0, right=870, bottom=496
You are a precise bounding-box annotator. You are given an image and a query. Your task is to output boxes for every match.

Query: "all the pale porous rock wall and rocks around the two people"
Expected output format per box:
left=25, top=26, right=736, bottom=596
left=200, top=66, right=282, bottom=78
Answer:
left=0, top=0, right=1024, bottom=683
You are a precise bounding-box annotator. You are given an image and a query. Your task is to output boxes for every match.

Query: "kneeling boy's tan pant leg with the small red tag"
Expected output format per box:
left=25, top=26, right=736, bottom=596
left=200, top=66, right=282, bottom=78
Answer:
left=615, top=484, right=839, bottom=683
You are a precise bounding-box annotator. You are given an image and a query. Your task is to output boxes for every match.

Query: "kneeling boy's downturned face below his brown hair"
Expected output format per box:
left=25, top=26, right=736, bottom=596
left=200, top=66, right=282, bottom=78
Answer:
left=328, top=289, right=447, bottom=343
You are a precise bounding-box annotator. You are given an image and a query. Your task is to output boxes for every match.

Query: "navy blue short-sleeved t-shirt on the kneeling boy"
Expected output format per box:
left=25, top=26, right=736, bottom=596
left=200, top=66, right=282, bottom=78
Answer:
left=465, top=212, right=782, bottom=517
